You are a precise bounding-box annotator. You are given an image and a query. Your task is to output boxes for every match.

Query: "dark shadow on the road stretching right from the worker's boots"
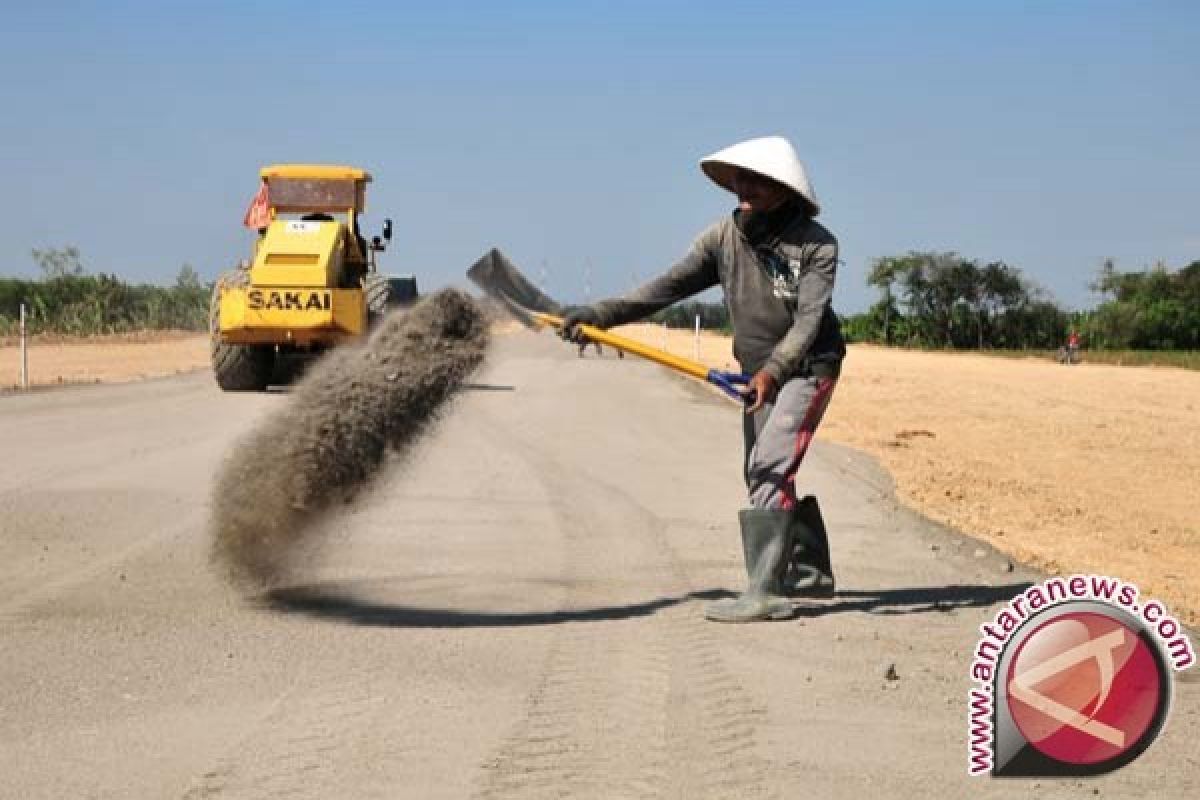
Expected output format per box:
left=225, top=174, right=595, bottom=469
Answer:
left=796, top=581, right=1033, bottom=618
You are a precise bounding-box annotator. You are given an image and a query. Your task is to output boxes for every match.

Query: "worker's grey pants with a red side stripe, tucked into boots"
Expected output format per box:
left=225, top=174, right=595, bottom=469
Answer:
left=742, top=375, right=838, bottom=510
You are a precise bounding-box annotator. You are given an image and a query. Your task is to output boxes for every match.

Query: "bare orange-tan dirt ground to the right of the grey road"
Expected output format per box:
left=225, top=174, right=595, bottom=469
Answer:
left=620, top=325, right=1200, bottom=625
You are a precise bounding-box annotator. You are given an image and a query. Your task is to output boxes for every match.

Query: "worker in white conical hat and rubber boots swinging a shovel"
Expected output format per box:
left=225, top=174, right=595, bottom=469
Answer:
left=563, top=137, right=846, bottom=622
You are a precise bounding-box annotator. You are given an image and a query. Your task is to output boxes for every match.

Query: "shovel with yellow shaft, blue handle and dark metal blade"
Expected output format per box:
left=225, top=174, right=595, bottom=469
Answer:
left=467, top=247, right=752, bottom=403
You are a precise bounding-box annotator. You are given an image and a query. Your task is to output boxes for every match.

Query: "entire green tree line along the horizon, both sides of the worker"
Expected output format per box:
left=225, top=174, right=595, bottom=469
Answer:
left=0, top=247, right=1200, bottom=350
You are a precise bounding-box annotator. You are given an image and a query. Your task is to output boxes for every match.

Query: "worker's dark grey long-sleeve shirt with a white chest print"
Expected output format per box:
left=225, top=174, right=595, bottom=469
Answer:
left=594, top=209, right=846, bottom=384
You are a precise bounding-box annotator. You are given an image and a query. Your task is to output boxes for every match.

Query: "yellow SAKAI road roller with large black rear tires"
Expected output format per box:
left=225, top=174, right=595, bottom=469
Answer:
left=209, top=164, right=416, bottom=391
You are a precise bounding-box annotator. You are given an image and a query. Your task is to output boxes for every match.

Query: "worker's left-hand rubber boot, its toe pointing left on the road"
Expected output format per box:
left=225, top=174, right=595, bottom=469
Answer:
left=704, top=509, right=792, bottom=622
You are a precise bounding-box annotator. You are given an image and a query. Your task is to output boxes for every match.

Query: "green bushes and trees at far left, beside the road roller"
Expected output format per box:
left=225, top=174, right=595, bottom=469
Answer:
left=0, top=247, right=212, bottom=336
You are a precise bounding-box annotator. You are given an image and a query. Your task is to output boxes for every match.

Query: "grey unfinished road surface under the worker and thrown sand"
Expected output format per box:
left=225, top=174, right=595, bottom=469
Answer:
left=0, top=333, right=1200, bottom=800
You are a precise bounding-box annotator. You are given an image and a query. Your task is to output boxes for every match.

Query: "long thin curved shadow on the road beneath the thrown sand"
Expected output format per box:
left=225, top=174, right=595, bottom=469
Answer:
left=262, top=584, right=728, bottom=627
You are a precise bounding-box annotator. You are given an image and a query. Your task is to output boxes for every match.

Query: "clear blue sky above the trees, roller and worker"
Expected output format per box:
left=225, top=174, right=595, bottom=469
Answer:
left=0, top=0, right=1200, bottom=312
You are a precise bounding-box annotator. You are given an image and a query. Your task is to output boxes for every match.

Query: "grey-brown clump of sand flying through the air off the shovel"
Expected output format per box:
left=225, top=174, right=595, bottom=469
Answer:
left=212, top=289, right=488, bottom=590
